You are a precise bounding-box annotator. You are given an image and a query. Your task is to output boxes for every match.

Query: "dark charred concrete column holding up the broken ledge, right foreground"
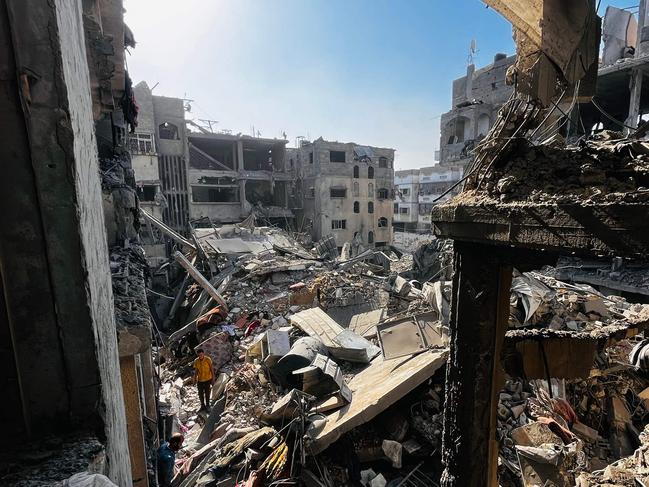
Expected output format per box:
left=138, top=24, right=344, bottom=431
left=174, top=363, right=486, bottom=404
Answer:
left=441, top=241, right=512, bottom=487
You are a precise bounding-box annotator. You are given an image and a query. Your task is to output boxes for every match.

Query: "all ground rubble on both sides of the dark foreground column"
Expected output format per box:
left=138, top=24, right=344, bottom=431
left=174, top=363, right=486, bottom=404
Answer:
left=146, top=218, right=649, bottom=487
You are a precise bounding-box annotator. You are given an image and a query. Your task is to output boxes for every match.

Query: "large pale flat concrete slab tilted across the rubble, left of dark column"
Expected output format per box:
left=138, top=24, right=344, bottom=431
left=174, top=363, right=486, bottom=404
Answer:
left=311, top=349, right=448, bottom=454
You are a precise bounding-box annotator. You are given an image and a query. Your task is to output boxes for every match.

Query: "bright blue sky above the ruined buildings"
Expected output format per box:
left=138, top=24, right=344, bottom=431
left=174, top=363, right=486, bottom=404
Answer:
left=125, top=0, right=633, bottom=169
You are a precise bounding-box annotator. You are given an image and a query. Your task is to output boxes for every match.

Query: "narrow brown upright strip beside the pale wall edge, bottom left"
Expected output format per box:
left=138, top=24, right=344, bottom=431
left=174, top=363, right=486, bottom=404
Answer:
left=119, top=355, right=149, bottom=487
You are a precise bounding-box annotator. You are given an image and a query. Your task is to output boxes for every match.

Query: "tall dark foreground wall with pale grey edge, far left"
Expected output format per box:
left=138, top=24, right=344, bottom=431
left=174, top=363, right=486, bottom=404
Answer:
left=0, top=0, right=131, bottom=486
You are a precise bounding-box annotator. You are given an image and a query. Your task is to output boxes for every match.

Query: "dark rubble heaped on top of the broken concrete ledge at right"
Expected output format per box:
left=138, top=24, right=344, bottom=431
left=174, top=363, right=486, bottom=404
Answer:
left=459, top=131, right=649, bottom=204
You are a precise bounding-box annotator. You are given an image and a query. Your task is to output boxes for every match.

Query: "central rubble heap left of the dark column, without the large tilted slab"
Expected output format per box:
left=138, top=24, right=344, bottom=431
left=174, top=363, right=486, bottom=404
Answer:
left=149, top=224, right=456, bottom=487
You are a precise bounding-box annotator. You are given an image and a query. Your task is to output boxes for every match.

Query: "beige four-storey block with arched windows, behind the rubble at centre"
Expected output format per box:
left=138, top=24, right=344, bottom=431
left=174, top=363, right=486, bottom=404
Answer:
left=294, top=138, right=394, bottom=248
